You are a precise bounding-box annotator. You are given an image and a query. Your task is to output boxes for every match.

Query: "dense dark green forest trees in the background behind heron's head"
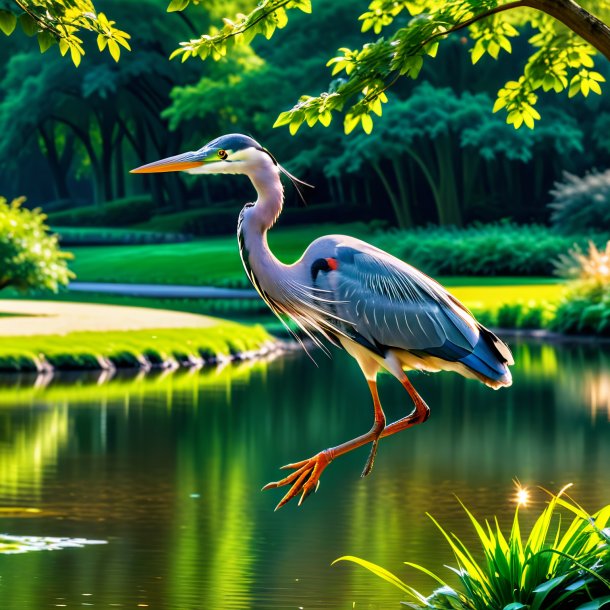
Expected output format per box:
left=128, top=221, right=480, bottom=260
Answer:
left=0, top=0, right=610, bottom=228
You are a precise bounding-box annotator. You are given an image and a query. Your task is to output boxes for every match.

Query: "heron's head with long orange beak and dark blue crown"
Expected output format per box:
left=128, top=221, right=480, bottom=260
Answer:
left=131, top=133, right=279, bottom=175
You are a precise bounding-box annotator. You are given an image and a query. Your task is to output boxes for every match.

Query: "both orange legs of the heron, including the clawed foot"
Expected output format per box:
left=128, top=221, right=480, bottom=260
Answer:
left=263, top=375, right=430, bottom=510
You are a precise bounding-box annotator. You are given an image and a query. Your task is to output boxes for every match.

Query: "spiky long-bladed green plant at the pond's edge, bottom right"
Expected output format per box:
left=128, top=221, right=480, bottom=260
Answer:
left=337, top=488, right=610, bottom=610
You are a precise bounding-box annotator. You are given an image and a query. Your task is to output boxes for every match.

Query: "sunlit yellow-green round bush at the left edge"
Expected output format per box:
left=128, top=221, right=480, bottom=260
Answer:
left=0, top=197, right=73, bottom=291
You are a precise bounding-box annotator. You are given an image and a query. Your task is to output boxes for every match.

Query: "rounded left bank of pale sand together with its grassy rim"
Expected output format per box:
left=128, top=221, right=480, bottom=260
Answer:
left=0, top=301, right=271, bottom=371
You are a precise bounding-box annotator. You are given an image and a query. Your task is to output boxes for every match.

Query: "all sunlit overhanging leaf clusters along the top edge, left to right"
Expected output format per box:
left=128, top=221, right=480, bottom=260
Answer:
left=0, top=0, right=610, bottom=134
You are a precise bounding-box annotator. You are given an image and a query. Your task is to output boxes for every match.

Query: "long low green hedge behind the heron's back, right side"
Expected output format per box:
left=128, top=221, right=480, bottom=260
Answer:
left=376, top=222, right=602, bottom=276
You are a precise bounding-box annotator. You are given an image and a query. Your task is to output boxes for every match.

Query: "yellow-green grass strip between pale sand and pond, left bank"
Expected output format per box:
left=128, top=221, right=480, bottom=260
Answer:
left=0, top=321, right=271, bottom=372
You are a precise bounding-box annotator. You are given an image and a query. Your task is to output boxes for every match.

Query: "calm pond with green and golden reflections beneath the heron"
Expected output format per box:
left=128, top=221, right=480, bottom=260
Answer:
left=0, top=342, right=610, bottom=610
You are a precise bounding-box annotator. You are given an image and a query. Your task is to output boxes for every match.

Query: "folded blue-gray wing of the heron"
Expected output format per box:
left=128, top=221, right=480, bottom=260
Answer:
left=325, top=242, right=479, bottom=359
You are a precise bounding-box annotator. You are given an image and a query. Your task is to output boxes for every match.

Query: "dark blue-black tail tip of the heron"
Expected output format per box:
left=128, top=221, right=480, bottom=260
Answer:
left=460, top=326, right=515, bottom=390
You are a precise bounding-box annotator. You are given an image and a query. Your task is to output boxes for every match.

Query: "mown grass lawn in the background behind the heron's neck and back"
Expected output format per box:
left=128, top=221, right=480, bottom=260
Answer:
left=70, top=223, right=563, bottom=302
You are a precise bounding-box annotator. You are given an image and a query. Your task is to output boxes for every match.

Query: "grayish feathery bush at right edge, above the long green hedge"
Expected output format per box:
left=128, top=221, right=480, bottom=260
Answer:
left=549, top=170, right=610, bottom=233
